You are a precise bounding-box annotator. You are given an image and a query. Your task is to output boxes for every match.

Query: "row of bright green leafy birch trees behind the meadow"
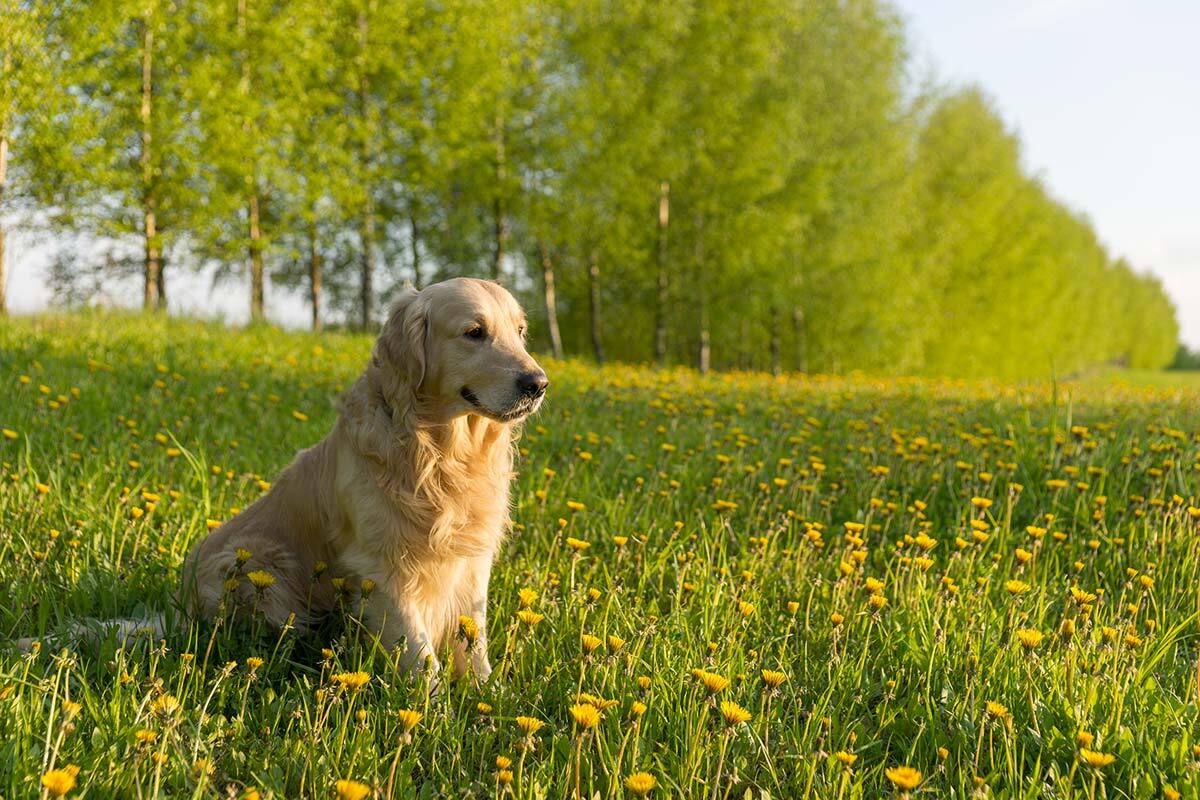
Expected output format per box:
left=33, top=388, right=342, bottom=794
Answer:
left=0, top=0, right=1177, bottom=377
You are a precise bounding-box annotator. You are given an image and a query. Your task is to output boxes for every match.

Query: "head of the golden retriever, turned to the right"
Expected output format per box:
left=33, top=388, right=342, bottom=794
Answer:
left=377, top=278, right=550, bottom=422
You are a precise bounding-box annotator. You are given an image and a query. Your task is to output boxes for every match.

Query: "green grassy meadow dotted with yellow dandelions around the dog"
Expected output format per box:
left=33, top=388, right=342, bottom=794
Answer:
left=0, top=317, right=1200, bottom=799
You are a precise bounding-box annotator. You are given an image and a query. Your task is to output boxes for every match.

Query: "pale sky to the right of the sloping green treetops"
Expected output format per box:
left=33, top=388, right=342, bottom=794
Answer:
left=896, top=0, right=1200, bottom=348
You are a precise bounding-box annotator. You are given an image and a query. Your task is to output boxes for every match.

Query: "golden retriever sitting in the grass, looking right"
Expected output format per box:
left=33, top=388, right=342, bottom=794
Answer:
left=12, top=278, right=550, bottom=680
